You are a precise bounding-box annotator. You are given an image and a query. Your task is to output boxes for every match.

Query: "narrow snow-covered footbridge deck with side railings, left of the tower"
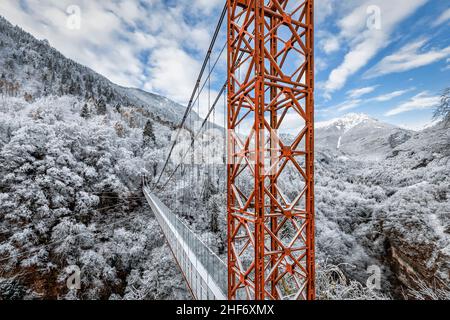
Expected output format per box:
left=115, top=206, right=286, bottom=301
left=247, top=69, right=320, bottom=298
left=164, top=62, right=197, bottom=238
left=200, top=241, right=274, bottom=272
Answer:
left=144, top=187, right=228, bottom=300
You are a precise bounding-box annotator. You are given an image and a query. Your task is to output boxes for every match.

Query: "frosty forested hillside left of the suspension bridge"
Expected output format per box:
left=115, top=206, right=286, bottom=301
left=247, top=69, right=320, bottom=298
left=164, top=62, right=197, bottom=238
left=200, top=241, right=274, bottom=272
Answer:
left=0, top=17, right=187, bottom=299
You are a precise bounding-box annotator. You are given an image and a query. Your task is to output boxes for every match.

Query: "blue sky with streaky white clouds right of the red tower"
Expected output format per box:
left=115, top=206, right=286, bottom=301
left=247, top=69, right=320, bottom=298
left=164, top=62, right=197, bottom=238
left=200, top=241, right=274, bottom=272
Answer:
left=316, top=0, right=450, bottom=129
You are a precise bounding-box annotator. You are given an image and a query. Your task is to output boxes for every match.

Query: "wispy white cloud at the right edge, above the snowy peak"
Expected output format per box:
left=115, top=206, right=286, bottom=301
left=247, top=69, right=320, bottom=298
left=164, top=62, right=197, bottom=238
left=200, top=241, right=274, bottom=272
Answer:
left=366, top=39, right=450, bottom=78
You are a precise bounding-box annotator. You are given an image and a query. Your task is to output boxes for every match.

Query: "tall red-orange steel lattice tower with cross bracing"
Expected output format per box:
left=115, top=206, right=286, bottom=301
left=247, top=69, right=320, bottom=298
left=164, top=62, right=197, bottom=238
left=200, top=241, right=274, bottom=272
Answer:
left=227, top=0, right=315, bottom=300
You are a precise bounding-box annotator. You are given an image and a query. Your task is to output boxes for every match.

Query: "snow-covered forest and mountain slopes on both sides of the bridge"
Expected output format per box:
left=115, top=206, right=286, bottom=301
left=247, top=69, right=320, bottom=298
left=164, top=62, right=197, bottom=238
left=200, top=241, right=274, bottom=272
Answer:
left=0, top=17, right=450, bottom=299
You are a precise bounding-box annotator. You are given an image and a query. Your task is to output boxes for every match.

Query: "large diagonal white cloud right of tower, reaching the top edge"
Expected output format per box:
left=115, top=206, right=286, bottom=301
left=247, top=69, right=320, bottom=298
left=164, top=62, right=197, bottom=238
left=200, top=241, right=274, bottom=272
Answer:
left=325, top=0, right=428, bottom=94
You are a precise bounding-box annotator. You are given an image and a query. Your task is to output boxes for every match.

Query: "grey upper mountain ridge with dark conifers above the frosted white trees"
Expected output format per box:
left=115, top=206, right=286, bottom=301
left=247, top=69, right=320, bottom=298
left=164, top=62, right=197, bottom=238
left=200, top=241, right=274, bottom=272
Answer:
left=0, top=15, right=198, bottom=126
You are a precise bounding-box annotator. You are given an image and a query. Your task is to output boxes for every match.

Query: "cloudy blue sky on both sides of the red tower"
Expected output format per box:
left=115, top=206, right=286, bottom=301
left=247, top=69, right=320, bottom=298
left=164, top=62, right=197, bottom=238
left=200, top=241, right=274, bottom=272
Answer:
left=0, top=0, right=450, bottom=129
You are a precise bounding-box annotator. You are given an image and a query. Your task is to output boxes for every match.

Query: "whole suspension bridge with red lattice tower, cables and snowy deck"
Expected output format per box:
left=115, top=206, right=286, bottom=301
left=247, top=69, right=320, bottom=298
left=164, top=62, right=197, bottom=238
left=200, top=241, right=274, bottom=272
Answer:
left=143, top=0, right=315, bottom=300
